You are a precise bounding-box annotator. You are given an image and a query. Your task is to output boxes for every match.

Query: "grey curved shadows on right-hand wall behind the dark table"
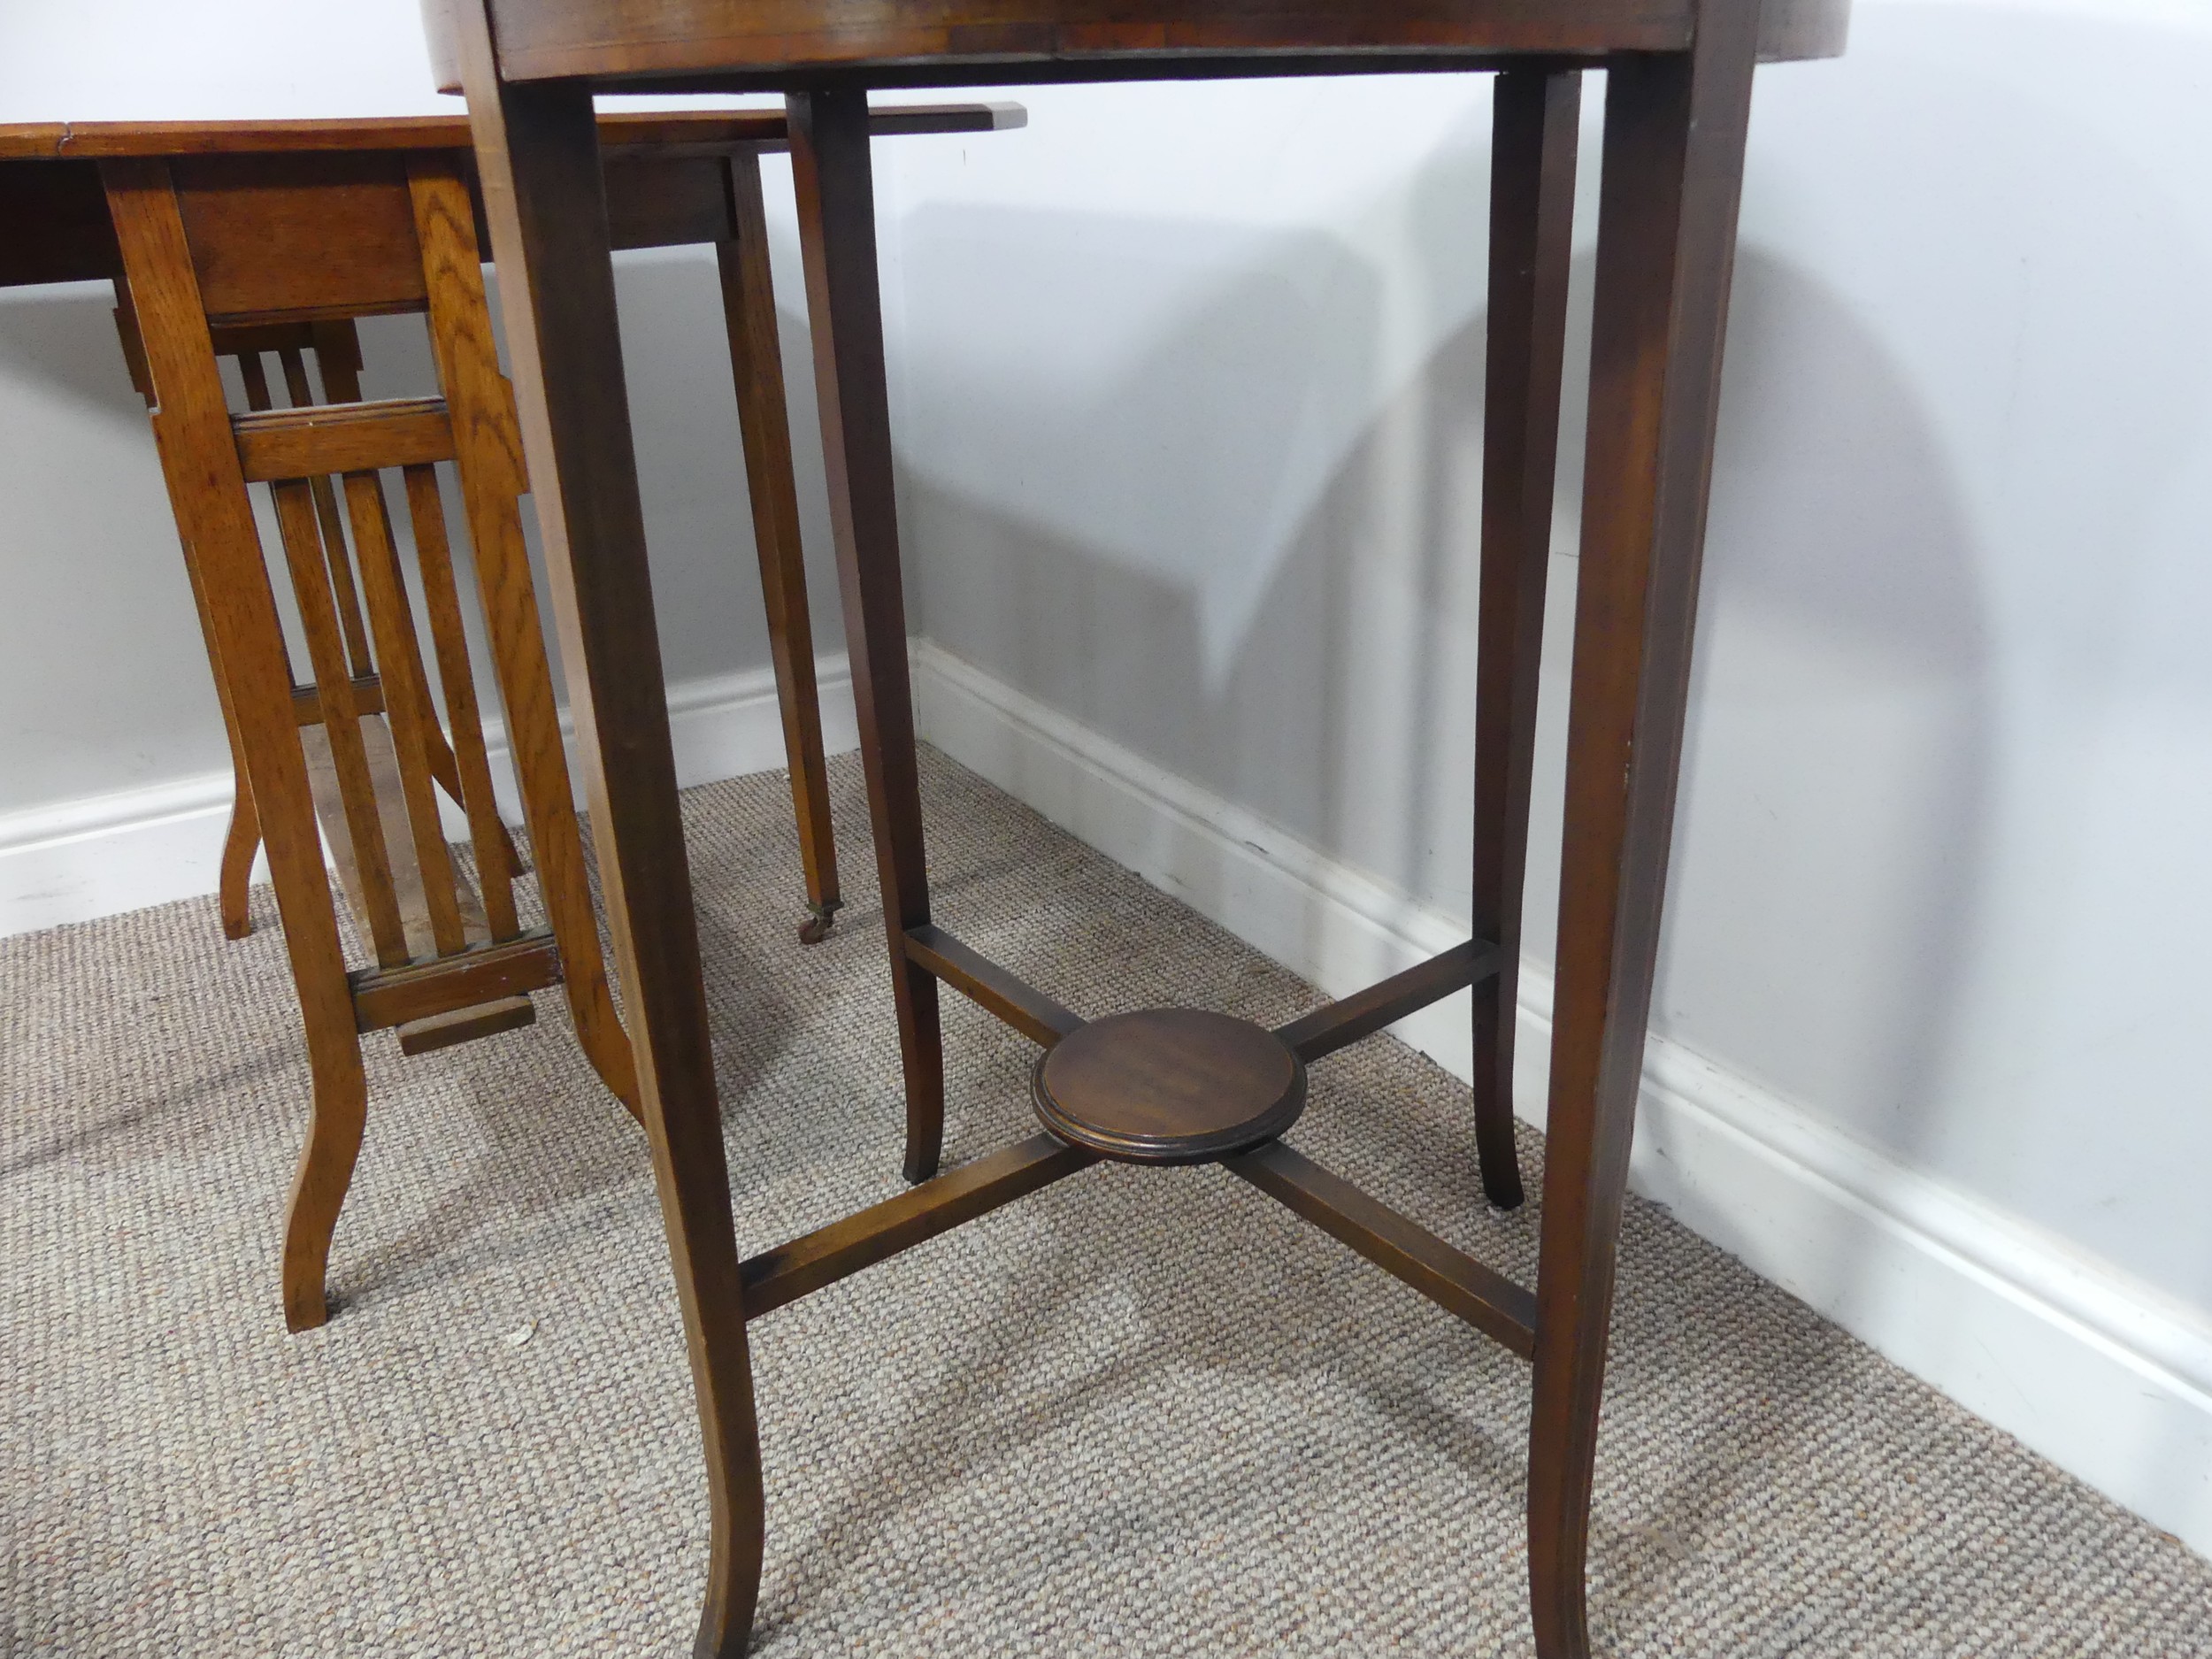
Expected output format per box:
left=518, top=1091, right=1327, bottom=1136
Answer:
left=905, top=175, right=1991, bottom=1168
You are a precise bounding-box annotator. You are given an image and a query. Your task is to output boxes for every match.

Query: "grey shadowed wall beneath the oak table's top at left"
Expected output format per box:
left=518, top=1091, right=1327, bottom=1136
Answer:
left=0, top=250, right=839, bottom=827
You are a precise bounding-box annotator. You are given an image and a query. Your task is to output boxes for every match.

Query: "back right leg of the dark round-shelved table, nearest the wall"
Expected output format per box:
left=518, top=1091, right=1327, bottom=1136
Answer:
left=1473, top=66, right=1582, bottom=1210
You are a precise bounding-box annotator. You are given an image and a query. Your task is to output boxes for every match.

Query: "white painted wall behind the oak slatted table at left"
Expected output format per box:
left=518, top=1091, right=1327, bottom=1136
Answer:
left=0, top=0, right=841, bottom=818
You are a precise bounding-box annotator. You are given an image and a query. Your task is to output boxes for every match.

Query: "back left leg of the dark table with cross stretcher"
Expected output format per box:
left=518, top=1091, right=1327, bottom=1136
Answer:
left=787, top=88, right=945, bottom=1181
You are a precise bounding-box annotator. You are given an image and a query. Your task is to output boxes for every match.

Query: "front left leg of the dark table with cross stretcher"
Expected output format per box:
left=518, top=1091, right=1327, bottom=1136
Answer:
left=451, top=4, right=764, bottom=1659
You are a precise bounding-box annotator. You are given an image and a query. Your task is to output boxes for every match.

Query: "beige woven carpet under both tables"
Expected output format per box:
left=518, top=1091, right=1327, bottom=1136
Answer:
left=0, top=757, right=2212, bottom=1659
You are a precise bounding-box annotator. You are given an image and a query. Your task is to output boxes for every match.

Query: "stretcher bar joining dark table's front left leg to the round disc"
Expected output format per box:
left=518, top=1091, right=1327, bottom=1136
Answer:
left=743, top=1135, right=1097, bottom=1318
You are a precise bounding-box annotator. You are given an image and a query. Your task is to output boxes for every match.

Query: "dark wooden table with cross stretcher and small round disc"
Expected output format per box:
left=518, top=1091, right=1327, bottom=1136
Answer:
left=427, top=0, right=1845, bottom=1659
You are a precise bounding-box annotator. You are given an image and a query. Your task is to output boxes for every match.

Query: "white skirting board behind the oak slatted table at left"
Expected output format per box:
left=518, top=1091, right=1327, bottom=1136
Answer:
left=0, top=655, right=861, bottom=938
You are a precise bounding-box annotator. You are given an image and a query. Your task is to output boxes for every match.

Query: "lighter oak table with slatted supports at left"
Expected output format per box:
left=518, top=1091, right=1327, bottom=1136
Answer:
left=0, top=104, right=1022, bottom=1330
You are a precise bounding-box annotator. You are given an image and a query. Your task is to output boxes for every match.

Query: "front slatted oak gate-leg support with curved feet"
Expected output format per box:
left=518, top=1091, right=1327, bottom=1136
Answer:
left=109, top=153, right=637, bottom=1330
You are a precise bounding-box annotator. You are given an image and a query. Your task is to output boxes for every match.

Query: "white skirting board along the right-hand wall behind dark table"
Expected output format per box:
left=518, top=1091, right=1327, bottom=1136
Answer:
left=914, top=641, right=2212, bottom=1555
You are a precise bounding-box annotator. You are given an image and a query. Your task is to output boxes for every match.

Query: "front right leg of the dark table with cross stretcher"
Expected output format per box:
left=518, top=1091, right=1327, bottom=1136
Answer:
left=1529, top=16, right=1759, bottom=1659
